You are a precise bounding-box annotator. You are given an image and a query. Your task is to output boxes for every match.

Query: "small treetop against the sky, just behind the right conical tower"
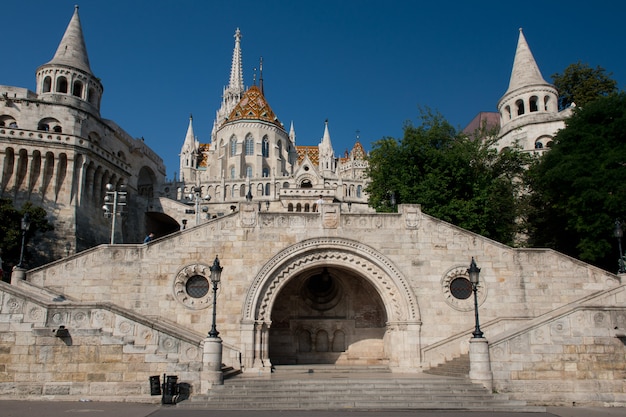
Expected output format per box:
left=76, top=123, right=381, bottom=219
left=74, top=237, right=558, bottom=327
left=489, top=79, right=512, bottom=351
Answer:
left=552, top=61, right=618, bottom=109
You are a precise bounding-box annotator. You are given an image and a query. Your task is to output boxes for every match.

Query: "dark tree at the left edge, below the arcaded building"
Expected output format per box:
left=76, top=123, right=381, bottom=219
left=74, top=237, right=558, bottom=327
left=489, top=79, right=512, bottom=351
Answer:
left=0, top=198, right=53, bottom=269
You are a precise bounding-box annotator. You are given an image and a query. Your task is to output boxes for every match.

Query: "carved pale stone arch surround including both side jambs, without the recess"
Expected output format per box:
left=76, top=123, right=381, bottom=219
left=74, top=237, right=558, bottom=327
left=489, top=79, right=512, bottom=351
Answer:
left=241, top=237, right=421, bottom=369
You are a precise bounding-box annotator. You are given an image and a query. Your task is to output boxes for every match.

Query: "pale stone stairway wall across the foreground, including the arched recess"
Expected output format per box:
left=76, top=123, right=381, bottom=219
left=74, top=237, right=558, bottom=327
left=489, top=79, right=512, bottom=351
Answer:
left=0, top=203, right=626, bottom=404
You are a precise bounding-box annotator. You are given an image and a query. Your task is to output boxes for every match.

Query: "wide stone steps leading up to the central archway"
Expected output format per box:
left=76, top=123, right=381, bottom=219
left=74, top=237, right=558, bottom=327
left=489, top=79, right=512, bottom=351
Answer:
left=177, top=366, right=545, bottom=412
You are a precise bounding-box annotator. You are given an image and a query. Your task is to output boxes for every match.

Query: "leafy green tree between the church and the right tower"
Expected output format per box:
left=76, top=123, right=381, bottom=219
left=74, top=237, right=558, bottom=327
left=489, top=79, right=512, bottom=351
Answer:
left=366, top=111, right=530, bottom=244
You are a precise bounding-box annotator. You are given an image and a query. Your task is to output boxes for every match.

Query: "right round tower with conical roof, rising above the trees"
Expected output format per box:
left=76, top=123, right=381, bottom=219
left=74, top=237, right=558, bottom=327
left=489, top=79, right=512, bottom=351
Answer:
left=498, top=28, right=566, bottom=150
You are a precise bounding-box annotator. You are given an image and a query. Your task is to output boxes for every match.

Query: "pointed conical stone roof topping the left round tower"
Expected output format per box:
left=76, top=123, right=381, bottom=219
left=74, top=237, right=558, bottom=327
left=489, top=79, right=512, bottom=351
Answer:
left=47, top=6, right=93, bottom=75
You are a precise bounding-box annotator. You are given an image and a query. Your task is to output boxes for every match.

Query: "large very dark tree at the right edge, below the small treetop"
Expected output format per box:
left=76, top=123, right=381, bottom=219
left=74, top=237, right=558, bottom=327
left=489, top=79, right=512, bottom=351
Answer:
left=527, top=92, right=626, bottom=272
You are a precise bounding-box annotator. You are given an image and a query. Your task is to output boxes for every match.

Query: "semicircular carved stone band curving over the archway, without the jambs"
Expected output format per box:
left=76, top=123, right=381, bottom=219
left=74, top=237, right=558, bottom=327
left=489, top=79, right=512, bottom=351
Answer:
left=242, top=237, right=421, bottom=324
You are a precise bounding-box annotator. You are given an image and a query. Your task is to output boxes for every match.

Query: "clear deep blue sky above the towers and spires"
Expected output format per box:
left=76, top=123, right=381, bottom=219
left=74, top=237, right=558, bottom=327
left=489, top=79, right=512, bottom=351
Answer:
left=0, top=0, right=626, bottom=178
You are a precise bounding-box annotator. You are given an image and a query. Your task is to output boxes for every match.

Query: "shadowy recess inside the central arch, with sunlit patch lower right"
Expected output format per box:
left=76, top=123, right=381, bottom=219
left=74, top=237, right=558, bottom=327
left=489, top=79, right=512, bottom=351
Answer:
left=269, top=266, right=388, bottom=365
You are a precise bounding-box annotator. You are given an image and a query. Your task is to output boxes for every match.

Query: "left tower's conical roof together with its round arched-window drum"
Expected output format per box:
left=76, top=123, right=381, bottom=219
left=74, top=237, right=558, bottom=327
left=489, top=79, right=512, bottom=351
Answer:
left=37, top=6, right=103, bottom=116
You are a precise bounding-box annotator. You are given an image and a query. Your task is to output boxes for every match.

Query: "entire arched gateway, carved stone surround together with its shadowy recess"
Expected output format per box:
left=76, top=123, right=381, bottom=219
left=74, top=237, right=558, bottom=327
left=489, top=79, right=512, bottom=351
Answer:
left=241, top=237, right=421, bottom=372
